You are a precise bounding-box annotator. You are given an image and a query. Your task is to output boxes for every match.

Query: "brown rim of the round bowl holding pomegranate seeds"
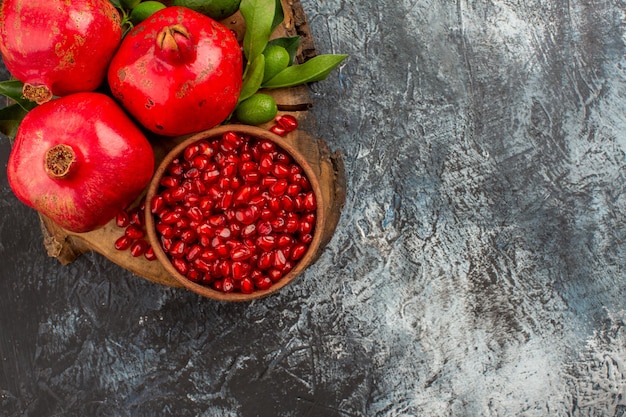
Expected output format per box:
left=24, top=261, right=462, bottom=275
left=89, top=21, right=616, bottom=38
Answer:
left=145, top=124, right=326, bottom=302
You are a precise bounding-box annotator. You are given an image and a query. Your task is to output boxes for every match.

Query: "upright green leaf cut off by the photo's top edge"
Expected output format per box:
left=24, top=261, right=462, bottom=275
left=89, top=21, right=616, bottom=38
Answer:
left=239, top=0, right=276, bottom=65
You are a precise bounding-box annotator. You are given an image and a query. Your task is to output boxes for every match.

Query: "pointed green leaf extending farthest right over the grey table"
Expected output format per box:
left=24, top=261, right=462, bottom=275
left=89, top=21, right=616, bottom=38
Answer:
left=262, top=54, right=348, bottom=88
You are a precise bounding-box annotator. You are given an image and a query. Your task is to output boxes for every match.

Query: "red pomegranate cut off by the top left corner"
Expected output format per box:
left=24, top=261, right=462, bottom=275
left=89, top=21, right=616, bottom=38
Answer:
left=0, top=0, right=122, bottom=104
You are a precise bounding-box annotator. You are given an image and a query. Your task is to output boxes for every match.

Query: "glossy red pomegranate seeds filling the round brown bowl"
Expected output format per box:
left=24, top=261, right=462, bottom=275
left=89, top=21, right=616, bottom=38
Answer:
left=150, top=132, right=317, bottom=293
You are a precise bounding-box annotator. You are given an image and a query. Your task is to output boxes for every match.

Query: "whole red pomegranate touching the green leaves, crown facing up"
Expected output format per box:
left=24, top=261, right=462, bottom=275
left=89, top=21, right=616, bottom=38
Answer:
left=108, top=6, right=243, bottom=136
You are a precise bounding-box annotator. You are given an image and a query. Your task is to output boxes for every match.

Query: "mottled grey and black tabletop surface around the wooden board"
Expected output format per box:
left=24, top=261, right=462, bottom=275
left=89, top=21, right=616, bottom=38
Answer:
left=0, top=0, right=626, bottom=417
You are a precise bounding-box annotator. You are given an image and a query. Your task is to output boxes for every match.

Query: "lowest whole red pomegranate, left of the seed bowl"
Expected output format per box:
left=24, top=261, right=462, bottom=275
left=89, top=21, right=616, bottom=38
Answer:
left=7, top=92, right=154, bottom=232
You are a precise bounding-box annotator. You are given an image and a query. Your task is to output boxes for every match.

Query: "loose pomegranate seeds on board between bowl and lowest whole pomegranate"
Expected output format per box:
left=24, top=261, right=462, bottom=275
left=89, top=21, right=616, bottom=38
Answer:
left=115, top=201, right=156, bottom=261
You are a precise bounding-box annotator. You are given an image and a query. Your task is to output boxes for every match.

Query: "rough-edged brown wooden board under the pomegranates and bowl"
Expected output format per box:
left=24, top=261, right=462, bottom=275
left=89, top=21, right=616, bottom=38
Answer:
left=34, top=0, right=346, bottom=287
